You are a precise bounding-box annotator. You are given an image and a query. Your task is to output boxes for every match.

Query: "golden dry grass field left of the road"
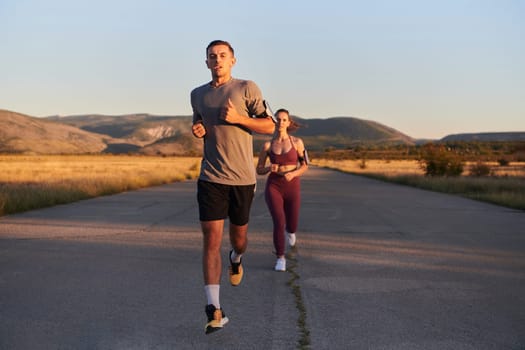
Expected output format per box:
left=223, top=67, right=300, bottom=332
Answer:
left=0, top=155, right=199, bottom=215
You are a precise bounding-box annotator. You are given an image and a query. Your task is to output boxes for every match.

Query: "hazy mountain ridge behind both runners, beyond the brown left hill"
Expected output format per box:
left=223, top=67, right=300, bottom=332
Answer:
left=50, top=114, right=414, bottom=154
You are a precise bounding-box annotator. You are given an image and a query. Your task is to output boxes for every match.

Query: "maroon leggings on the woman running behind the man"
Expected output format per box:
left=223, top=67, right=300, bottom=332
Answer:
left=264, top=173, right=301, bottom=256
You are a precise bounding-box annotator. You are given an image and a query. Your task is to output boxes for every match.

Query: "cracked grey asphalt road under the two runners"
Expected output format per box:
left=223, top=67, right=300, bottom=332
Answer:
left=0, top=168, right=525, bottom=350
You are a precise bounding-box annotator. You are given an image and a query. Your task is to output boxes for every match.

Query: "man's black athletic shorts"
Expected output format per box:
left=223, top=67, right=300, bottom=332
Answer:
left=197, top=180, right=255, bottom=226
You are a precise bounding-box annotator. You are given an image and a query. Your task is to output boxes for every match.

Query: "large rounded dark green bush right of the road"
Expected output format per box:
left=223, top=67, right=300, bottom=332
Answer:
left=419, top=144, right=463, bottom=176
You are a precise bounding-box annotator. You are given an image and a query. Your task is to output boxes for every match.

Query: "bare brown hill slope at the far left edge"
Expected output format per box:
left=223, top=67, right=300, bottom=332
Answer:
left=0, top=109, right=118, bottom=154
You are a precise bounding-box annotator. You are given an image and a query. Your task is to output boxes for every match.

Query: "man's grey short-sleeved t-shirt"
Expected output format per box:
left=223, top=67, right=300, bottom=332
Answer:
left=191, top=79, right=265, bottom=185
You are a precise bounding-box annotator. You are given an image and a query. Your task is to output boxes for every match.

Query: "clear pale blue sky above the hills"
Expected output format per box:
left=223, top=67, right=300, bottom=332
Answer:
left=0, top=0, right=525, bottom=138
